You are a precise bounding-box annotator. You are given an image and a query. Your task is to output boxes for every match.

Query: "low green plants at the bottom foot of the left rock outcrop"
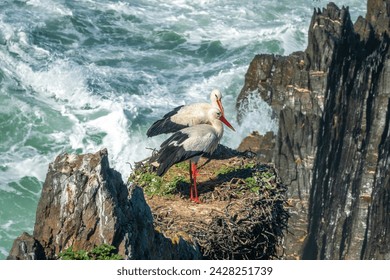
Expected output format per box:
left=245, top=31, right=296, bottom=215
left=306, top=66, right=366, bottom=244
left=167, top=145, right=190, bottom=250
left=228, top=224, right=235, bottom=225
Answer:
left=59, top=244, right=123, bottom=260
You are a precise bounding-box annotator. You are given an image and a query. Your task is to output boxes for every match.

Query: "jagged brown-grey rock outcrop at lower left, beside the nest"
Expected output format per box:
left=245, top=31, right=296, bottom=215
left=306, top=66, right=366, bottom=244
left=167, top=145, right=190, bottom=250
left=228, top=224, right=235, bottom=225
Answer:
left=8, top=150, right=201, bottom=259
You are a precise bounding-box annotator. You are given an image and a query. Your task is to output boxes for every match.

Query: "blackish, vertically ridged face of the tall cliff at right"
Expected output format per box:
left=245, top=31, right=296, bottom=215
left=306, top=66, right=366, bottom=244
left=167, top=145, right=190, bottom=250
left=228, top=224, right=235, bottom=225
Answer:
left=303, top=1, right=390, bottom=259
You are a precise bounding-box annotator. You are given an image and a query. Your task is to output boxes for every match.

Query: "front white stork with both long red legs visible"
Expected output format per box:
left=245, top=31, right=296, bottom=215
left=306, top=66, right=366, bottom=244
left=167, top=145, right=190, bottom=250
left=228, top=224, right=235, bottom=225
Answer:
left=157, top=108, right=234, bottom=203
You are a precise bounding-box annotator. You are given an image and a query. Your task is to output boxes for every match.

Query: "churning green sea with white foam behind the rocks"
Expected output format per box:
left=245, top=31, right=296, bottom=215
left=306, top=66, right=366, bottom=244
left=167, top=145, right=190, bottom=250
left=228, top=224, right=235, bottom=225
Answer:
left=0, top=0, right=366, bottom=259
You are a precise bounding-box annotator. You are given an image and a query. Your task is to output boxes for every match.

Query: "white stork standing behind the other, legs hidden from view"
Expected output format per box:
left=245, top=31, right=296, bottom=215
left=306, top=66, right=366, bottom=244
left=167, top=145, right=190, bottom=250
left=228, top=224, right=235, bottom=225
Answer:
left=146, top=89, right=224, bottom=137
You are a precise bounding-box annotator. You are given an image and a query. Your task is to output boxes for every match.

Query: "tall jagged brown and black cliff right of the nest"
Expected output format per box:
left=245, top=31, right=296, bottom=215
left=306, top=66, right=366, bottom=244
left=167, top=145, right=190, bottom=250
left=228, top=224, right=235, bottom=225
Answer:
left=237, top=0, right=390, bottom=259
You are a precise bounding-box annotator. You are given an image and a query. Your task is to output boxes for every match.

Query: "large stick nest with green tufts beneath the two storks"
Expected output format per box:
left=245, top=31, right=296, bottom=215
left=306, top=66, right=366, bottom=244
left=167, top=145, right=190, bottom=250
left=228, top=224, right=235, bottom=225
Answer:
left=129, top=152, right=289, bottom=260
